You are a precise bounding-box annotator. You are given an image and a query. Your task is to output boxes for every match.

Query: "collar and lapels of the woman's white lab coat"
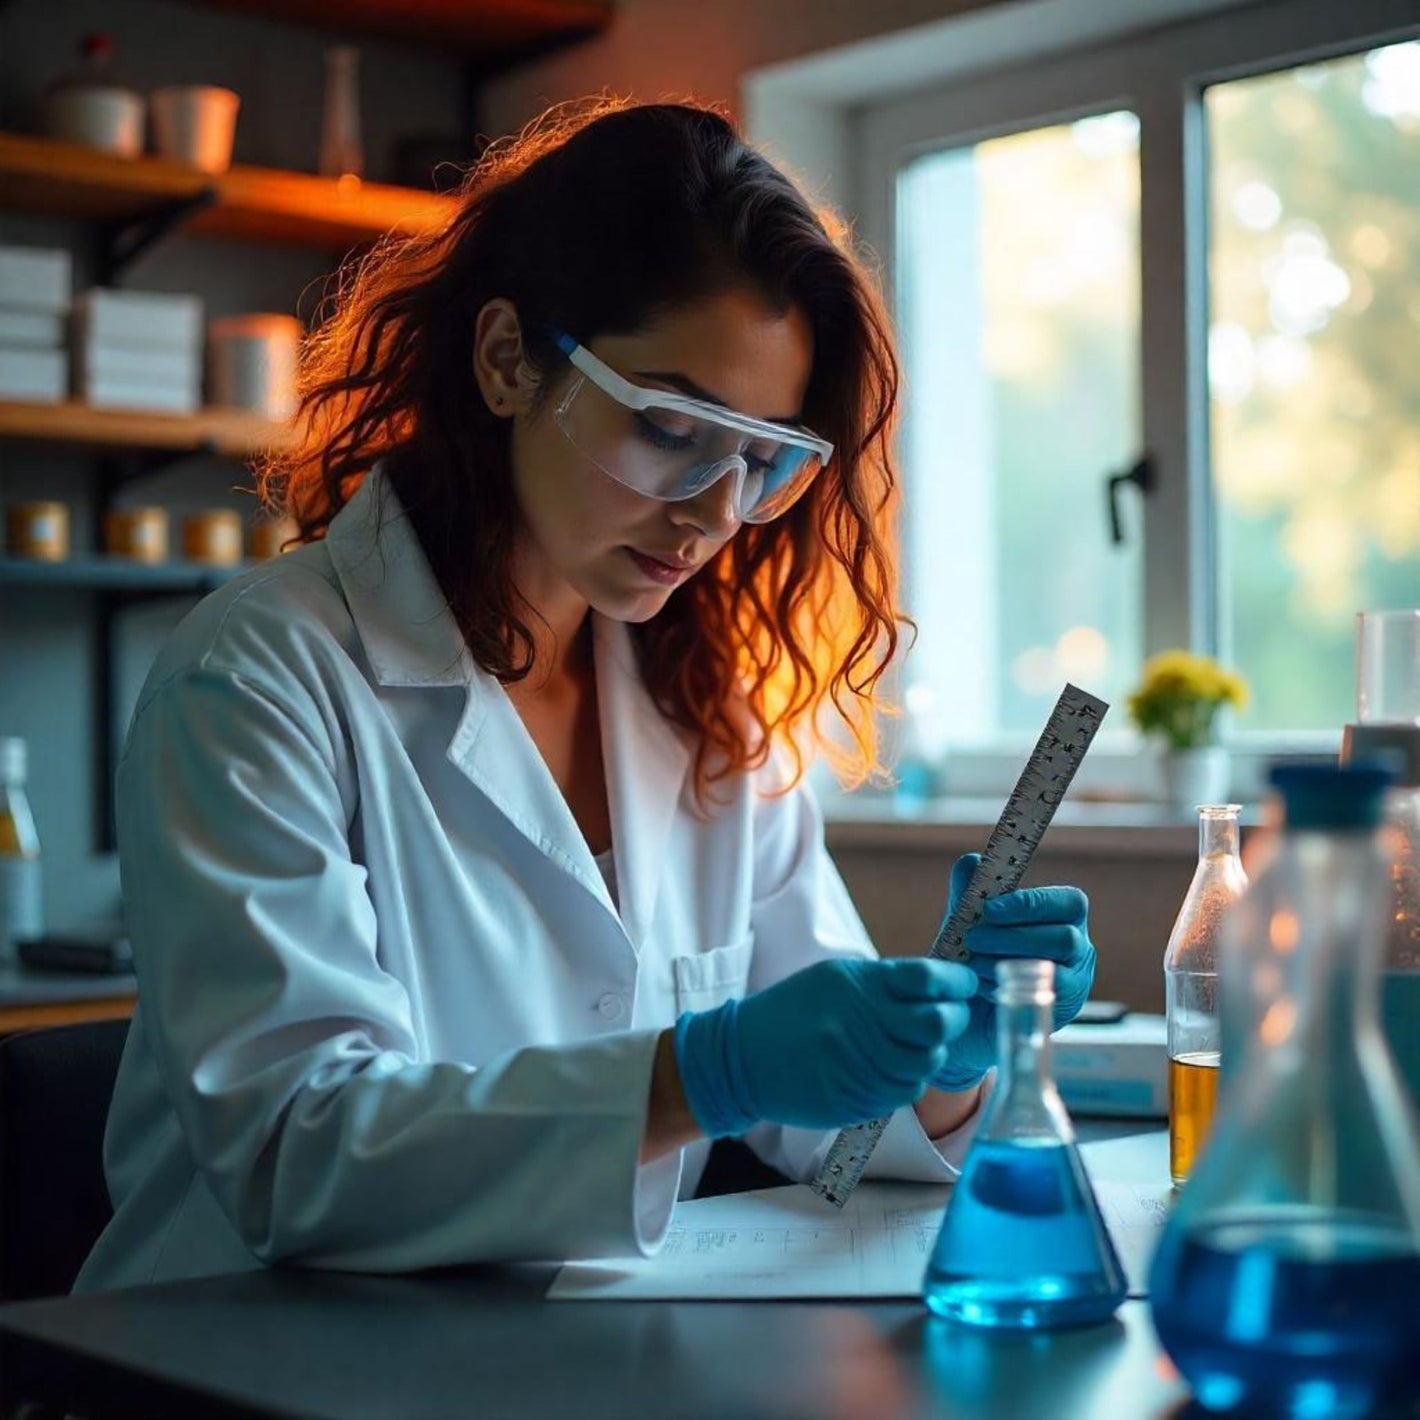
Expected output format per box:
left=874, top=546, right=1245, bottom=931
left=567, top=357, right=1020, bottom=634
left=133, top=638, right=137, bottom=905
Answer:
left=325, top=467, right=692, bottom=947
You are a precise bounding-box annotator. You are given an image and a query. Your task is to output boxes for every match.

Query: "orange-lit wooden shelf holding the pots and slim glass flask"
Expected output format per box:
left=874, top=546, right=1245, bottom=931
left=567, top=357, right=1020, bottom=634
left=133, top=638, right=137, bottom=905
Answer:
left=0, top=133, right=457, bottom=251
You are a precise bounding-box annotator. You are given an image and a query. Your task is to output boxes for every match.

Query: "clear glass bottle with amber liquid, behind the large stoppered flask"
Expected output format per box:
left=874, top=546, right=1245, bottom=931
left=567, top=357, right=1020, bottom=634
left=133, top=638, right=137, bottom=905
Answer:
left=1163, top=804, right=1247, bottom=1187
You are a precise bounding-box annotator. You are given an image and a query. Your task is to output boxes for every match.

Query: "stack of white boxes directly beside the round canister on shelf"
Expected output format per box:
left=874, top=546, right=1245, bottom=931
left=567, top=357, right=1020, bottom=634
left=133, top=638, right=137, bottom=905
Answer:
left=74, top=288, right=203, bottom=415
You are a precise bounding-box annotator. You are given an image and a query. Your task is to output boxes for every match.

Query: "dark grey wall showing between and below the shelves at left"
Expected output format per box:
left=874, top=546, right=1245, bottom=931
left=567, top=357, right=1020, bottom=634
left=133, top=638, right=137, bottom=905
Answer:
left=0, top=0, right=464, bottom=927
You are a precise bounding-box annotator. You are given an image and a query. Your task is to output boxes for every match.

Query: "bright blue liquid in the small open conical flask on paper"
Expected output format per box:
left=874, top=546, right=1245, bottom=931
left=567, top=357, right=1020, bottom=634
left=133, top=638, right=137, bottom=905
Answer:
left=923, top=1139, right=1126, bottom=1326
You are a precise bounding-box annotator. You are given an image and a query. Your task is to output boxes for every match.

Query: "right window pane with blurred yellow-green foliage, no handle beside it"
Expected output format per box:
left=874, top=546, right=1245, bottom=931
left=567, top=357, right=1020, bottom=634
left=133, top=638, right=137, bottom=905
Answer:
left=1204, top=41, right=1420, bottom=733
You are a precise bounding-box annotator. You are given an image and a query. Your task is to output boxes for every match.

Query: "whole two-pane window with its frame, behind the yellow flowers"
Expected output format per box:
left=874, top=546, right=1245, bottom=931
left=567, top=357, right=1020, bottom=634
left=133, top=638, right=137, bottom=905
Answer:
left=851, top=0, right=1420, bottom=792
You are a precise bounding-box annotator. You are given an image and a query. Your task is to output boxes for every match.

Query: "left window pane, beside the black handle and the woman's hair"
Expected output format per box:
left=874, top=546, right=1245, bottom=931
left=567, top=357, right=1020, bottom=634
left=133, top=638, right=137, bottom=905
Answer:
left=896, top=111, right=1142, bottom=744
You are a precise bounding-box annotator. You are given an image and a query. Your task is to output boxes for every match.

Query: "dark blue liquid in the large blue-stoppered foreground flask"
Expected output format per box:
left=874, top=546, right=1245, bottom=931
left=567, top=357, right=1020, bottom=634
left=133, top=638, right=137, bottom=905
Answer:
left=1152, top=1208, right=1420, bottom=1420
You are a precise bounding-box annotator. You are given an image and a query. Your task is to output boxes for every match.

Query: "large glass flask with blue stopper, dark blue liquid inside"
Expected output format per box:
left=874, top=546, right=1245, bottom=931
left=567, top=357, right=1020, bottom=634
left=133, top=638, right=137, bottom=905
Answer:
left=1150, top=764, right=1420, bottom=1420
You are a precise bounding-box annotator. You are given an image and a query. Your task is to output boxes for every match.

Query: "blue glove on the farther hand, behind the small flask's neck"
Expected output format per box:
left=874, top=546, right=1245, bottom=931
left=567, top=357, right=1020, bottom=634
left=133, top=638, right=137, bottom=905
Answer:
left=932, top=853, right=1095, bottom=1091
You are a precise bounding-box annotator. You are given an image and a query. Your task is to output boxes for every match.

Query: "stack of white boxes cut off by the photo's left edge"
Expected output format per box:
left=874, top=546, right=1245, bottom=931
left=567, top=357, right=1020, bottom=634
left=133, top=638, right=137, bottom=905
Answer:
left=0, top=246, right=74, bottom=405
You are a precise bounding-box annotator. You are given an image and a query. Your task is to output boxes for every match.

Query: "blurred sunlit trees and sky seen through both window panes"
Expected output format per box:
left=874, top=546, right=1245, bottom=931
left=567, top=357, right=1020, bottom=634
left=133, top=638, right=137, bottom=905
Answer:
left=899, top=43, right=1420, bottom=743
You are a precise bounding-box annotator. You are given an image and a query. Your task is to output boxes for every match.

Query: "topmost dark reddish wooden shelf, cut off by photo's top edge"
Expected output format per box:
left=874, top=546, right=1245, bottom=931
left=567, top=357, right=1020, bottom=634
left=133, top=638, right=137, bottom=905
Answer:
left=168, top=0, right=616, bottom=53
